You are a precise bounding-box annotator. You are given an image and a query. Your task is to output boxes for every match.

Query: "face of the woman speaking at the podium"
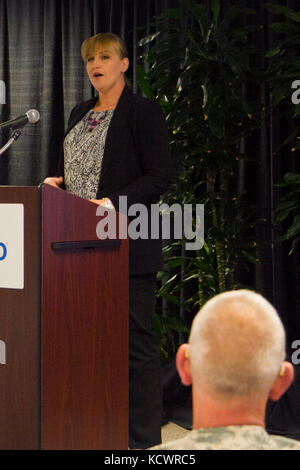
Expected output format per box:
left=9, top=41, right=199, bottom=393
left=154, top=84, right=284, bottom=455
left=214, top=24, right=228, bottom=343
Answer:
left=86, top=44, right=129, bottom=92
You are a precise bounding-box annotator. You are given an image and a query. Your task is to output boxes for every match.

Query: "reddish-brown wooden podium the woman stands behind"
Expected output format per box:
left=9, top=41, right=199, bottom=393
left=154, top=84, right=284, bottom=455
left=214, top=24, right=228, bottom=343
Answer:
left=0, top=185, right=128, bottom=450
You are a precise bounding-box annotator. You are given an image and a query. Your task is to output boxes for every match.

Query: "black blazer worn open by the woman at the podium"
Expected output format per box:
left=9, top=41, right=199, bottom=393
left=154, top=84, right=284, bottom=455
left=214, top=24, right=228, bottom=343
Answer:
left=58, top=86, right=172, bottom=275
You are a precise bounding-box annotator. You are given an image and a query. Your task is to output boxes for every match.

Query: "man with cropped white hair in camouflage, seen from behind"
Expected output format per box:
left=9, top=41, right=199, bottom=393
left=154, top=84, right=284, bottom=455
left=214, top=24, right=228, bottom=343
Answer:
left=153, top=290, right=300, bottom=450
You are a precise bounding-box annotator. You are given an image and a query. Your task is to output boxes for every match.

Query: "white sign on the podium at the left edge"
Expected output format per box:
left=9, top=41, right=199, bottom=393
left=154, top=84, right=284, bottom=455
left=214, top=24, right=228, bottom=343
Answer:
left=0, top=204, right=24, bottom=289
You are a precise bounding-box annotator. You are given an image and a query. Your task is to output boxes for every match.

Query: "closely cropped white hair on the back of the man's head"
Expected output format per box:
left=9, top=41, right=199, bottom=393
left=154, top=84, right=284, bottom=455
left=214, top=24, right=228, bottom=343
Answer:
left=189, top=289, right=285, bottom=398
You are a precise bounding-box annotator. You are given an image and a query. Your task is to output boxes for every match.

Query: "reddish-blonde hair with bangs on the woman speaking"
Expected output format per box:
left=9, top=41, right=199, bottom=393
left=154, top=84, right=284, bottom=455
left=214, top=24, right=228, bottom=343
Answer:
left=81, top=33, right=128, bottom=62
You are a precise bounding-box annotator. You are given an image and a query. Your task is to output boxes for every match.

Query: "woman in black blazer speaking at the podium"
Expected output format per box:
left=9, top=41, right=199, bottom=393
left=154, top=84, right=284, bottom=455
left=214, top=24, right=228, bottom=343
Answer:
left=45, top=33, right=171, bottom=449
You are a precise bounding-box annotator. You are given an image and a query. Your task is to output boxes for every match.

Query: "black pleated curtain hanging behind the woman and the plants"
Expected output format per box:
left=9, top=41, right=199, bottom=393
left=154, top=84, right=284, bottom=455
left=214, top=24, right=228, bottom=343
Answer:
left=0, top=0, right=300, bottom=439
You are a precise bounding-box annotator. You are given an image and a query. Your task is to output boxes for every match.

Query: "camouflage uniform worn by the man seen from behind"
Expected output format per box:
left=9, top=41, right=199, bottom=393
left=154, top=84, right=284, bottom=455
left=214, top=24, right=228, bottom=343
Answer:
left=152, top=425, right=300, bottom=450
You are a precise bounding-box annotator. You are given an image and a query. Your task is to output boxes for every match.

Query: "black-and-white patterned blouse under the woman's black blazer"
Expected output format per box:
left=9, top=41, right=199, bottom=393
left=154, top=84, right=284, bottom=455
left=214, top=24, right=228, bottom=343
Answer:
left=64, top=110, right=114, bottom=199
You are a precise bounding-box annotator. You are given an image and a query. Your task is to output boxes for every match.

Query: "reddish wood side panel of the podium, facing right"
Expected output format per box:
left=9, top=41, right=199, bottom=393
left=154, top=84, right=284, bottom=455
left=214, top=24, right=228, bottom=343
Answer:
left=41, top=185, right=129, bottom=449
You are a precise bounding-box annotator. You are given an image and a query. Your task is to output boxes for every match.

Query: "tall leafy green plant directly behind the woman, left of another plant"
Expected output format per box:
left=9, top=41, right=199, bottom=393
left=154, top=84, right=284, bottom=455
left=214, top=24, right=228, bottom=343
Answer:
left=137, top=0, right=263, bottom=358
